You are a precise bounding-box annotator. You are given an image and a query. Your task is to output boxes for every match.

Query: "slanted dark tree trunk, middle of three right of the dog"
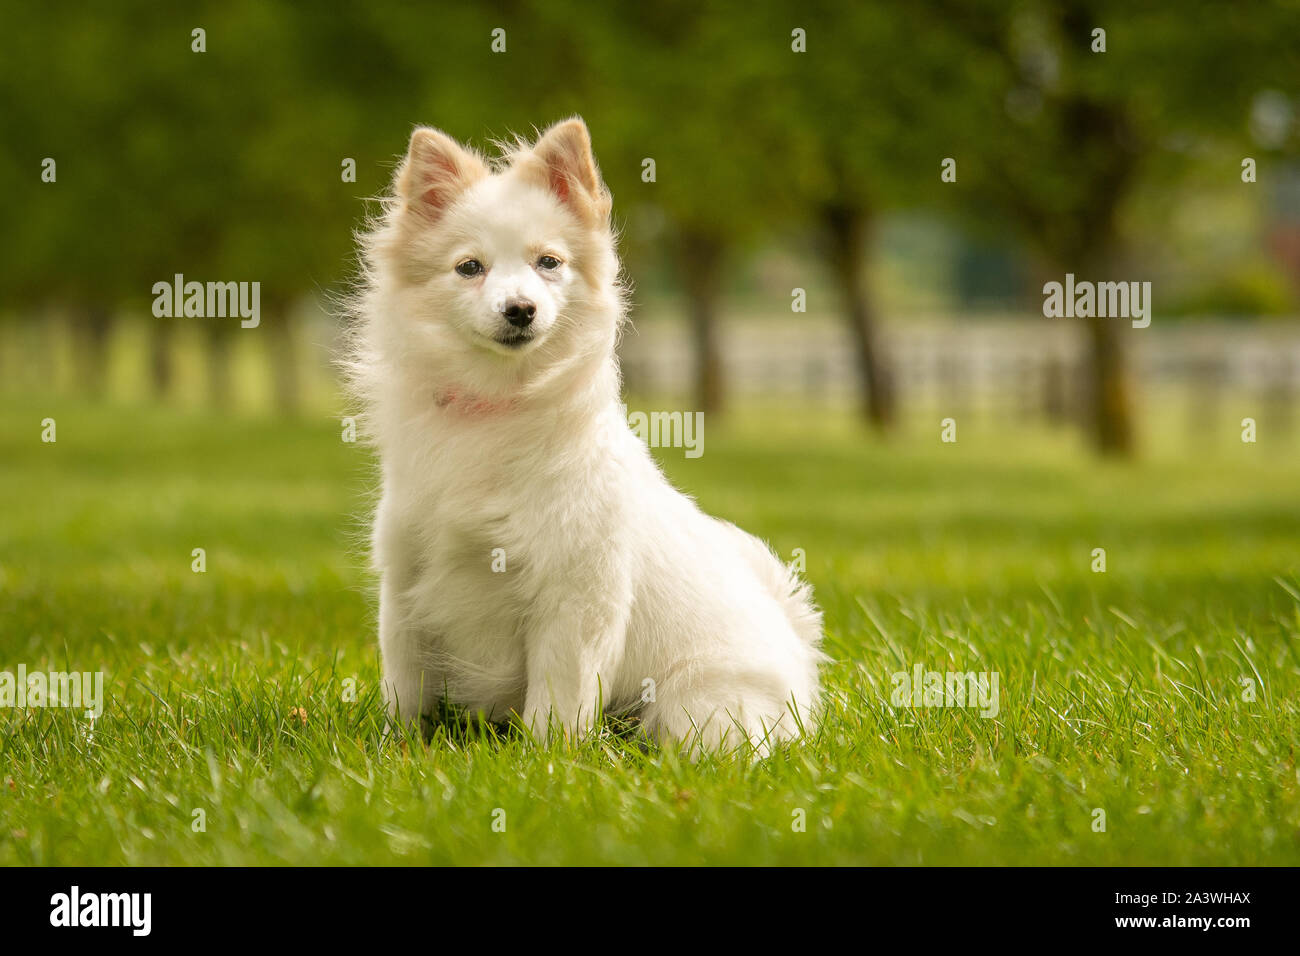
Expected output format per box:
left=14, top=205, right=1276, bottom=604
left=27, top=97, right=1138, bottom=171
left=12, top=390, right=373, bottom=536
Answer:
left=822, top=204, right=894, bottom=432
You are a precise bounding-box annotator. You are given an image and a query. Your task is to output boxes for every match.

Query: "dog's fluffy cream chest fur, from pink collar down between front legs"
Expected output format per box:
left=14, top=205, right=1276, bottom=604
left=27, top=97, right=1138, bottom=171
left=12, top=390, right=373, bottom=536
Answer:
left=380, top=408, right=608, bottom=717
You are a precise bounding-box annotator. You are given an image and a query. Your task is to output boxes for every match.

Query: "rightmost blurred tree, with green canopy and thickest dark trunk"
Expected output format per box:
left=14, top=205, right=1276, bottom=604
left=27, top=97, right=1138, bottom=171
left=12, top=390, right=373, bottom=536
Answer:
left=927, top=0, right=1297, bottom=455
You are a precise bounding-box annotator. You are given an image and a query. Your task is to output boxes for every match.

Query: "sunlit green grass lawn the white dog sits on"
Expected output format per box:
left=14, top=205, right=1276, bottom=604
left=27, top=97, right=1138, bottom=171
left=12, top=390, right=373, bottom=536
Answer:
left=0, top=401, right=1300, bottom=865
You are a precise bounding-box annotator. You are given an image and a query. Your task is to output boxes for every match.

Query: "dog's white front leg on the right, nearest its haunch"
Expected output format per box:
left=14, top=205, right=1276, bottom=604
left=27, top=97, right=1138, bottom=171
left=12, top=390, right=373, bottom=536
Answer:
left=520, top=594, right=627, bottom=743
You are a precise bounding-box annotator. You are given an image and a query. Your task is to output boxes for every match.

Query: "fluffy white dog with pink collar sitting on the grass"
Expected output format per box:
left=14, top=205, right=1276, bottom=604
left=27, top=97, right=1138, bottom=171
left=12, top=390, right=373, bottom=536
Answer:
left=346, top=118, right=823, bottom=753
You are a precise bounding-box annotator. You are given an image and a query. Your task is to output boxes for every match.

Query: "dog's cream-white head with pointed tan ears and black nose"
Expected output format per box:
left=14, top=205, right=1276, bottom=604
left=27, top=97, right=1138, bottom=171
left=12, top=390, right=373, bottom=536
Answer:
left=372, top=118, right=620, bottom=389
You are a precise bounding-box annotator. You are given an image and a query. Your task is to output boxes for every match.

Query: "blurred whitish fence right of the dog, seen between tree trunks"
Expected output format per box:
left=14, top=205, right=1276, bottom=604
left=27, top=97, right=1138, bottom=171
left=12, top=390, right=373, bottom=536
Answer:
left=620, top=316, right=1300, bottom=418
